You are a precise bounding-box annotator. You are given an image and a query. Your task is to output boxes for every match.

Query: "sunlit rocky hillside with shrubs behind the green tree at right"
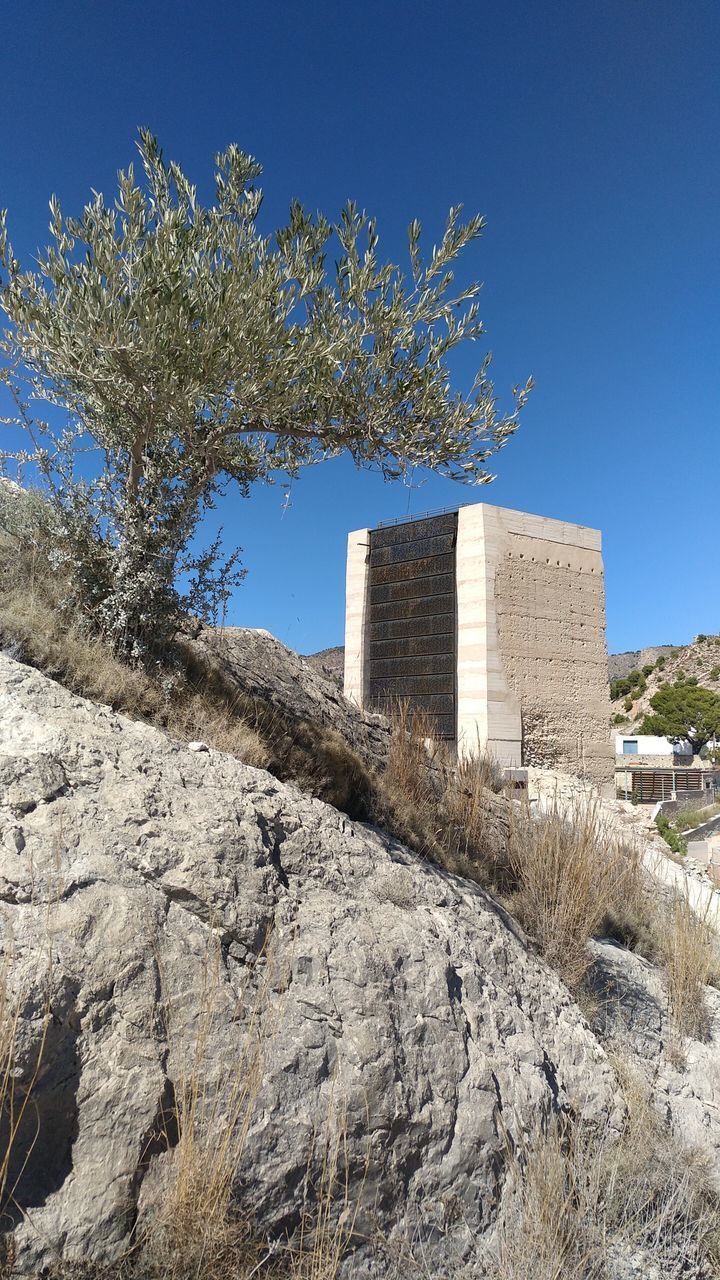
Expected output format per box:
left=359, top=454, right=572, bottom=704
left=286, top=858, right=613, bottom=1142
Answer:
left=611, top=636, right=720, bottom=730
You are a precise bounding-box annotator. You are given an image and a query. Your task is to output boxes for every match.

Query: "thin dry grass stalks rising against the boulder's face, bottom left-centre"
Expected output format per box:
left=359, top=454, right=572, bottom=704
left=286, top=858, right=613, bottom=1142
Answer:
left=32, top=933, right=358, bottom=1280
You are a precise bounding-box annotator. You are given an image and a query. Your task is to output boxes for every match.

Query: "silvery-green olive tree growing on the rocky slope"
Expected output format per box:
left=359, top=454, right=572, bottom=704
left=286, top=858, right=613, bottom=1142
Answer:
left=0, top=131, right=530, bottom=657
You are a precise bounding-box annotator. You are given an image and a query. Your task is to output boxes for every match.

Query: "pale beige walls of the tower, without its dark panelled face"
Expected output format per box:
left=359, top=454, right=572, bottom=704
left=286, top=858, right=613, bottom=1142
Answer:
left=346, top=503, right=614, bottom=790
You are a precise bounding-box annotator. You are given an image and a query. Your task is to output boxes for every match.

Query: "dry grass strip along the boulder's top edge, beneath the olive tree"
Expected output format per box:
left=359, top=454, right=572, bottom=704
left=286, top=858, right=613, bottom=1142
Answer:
left=0, top=536, right=373, bottom=819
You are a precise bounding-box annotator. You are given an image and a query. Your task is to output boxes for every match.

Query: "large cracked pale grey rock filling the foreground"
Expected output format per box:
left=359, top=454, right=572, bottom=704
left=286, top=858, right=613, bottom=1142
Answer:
left=0, top=655, right=620, bottom=1275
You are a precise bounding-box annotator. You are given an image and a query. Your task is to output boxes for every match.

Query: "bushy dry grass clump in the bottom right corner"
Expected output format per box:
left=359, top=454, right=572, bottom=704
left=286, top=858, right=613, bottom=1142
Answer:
left=489, top=1060, right=720, bottom=1280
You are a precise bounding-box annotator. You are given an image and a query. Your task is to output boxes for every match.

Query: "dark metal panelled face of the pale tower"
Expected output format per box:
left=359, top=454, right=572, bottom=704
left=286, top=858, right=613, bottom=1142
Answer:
left=365, top=512, right=457, bottom=739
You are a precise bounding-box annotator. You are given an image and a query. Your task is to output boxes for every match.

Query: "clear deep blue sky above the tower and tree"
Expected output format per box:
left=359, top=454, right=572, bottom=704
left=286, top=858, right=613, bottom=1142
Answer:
left=0, top=0, right=720, bottom=652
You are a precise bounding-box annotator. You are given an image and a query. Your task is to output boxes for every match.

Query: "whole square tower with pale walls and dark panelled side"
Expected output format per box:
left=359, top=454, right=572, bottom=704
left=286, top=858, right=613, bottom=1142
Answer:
left=345, top=503, right=614, bottom=790
